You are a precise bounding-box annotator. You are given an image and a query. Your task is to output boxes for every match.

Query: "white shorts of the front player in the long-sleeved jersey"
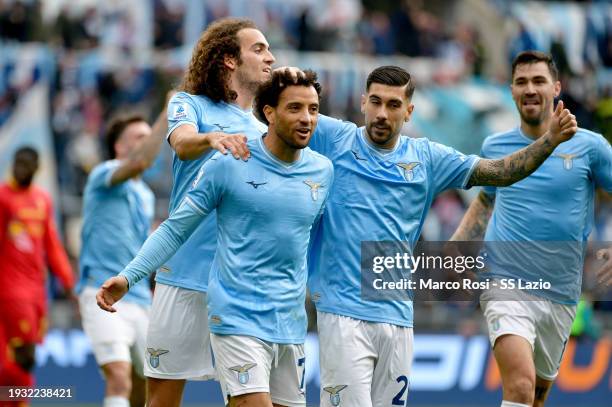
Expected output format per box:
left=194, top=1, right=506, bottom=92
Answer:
left=211, top=334, right=306, bottom=407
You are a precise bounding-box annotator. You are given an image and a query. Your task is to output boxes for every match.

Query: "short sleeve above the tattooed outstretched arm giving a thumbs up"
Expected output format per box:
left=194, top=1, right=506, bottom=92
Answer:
left=429, top=142, right=480, bottom=194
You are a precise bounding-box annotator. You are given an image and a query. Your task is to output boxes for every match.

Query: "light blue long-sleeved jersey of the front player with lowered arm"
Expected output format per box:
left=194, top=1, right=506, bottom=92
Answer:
left=121, top=138, right=333, bottom=343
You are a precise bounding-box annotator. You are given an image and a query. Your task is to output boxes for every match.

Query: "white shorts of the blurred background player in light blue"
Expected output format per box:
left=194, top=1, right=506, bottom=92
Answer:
left=79, top=287, right=149, bottom=376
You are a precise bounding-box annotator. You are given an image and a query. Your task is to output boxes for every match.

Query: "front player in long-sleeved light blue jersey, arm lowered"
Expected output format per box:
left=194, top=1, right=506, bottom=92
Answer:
left=98, top=71, right=333, bottom=407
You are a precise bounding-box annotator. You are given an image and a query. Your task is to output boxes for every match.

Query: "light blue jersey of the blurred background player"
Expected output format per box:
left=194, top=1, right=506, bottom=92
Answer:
left=77, top=160, right=155, bottom=305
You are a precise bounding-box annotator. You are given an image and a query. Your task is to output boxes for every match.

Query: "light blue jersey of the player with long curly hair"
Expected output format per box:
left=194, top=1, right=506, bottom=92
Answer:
left=155, top=92, right=266, bottom=291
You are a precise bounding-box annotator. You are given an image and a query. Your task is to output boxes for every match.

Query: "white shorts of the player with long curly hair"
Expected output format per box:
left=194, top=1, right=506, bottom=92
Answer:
left=144, top=283, right=216, bottom=380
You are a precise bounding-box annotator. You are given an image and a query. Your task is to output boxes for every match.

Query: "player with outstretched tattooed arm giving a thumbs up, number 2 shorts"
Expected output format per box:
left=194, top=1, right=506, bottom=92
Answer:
left=308, top=66, right=576, bottom=407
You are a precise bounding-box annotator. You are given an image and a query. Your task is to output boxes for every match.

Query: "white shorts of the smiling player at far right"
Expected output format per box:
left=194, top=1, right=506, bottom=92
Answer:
left=480, top=288, right=576, bottom=381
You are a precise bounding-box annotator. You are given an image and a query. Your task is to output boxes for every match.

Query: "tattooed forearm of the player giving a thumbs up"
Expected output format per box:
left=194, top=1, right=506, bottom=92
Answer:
left=468, top=136, right=555, bottom=187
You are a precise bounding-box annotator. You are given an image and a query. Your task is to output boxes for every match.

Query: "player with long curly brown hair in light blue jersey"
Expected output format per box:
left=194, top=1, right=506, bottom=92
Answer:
left=95, top=19, right=274, bottom=407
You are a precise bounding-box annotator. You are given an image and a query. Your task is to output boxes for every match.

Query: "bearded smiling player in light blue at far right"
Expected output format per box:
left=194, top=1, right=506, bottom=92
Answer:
left=451, top=51, right=612, bottom=407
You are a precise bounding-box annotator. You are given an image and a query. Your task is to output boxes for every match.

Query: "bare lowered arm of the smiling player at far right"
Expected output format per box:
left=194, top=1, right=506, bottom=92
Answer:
left=449, top=191, right=495, bottom=242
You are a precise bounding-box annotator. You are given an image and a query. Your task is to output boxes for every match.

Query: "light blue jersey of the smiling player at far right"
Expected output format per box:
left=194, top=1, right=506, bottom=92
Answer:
left=482, top=128, right=612, bottom=304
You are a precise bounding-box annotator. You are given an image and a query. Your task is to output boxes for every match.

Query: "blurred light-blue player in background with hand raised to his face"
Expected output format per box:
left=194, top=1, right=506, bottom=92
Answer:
left=78, top=111, right=166, bottom=407
